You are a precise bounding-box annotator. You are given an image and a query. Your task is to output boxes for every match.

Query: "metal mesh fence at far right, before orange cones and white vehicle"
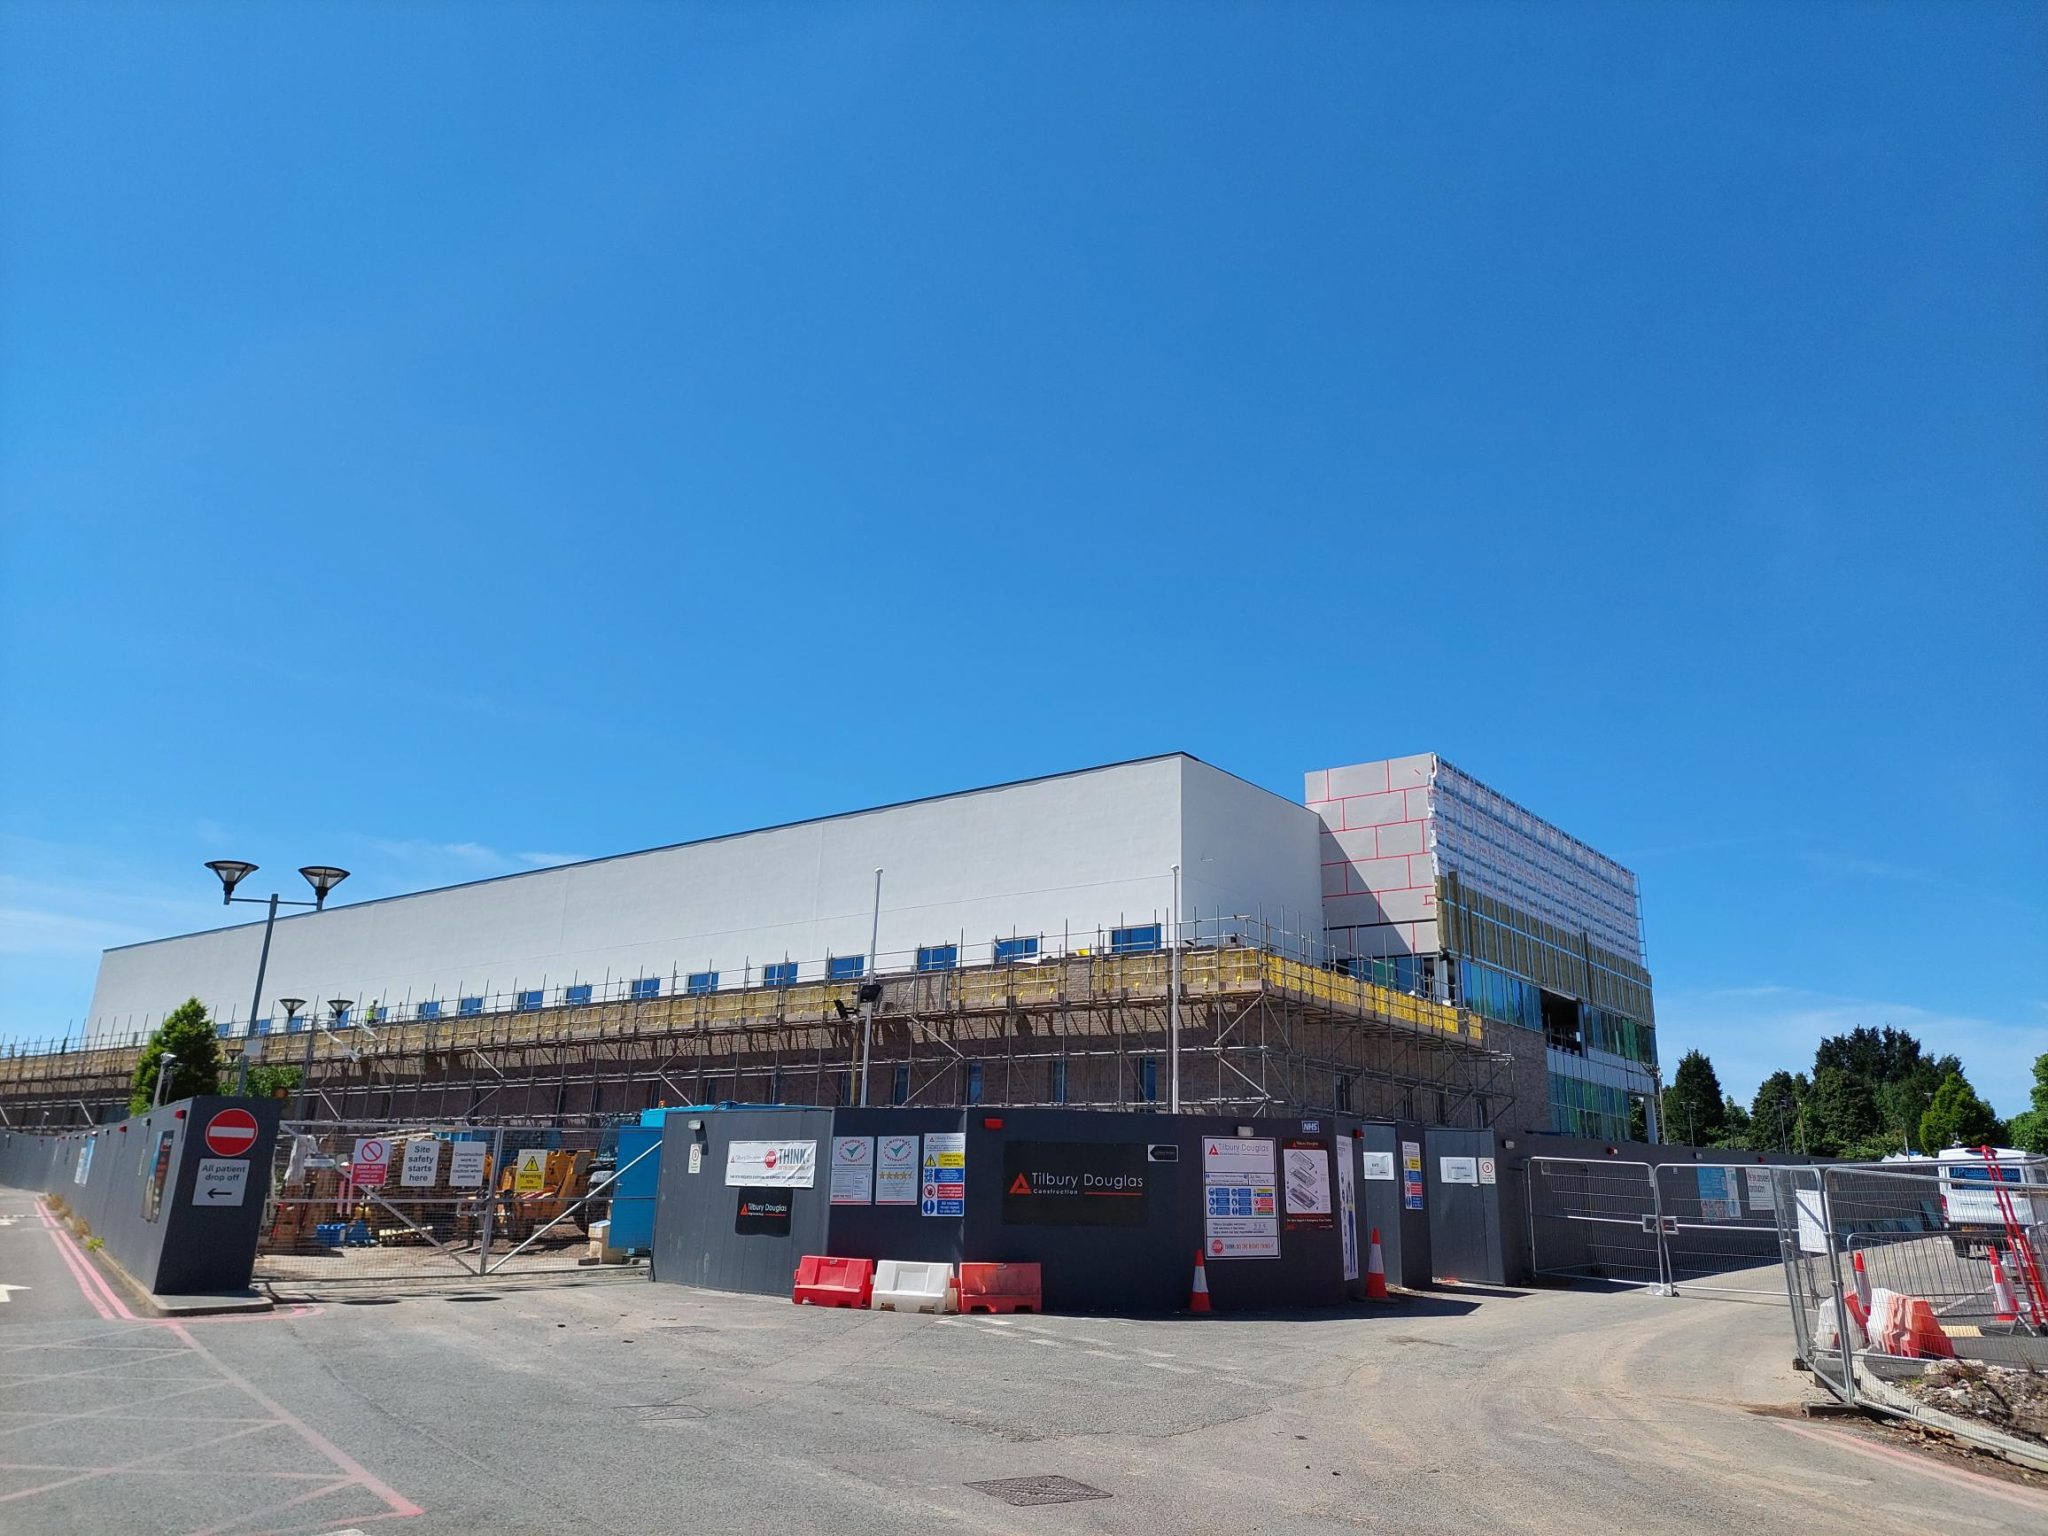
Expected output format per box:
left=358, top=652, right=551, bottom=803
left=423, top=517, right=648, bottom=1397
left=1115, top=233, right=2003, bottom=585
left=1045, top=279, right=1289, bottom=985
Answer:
left=1769, top=1155, right=2048, bottom=1413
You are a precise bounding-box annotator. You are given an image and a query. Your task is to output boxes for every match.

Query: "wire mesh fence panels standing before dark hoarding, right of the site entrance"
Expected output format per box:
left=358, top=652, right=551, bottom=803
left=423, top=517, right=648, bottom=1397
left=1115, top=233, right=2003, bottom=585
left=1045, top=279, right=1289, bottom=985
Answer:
left=1526, top=1157, right=1784, bottom=1300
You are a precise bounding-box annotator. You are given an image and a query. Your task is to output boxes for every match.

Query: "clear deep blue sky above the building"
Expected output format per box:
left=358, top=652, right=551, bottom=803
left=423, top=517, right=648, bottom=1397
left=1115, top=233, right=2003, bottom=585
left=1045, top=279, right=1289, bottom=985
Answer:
left=0, top=2, right=2048, bottom=1112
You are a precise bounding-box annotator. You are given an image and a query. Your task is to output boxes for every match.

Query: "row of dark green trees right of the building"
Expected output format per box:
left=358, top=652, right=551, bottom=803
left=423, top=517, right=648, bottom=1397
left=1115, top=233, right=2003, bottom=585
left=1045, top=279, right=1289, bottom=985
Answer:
left=1663, top=1026, right=2048, bottom=1161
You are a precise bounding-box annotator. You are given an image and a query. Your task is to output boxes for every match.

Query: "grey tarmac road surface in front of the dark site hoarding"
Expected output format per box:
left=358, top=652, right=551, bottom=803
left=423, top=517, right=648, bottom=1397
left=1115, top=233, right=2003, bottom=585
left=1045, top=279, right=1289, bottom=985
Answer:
left=0, top=1190, right=2048, bottom=1536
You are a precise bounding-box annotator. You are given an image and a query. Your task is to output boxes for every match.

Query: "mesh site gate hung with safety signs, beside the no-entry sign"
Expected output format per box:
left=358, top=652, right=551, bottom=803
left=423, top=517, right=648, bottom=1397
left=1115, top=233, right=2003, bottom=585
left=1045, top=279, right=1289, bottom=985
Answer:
left=256, top=1120, right=655, bottom=1284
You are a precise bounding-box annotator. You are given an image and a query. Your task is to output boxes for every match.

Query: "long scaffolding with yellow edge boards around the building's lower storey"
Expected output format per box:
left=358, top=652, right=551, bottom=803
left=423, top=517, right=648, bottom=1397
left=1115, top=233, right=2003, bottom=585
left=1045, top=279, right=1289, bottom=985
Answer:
left=0, top=942, right=1542, bottom=1128
